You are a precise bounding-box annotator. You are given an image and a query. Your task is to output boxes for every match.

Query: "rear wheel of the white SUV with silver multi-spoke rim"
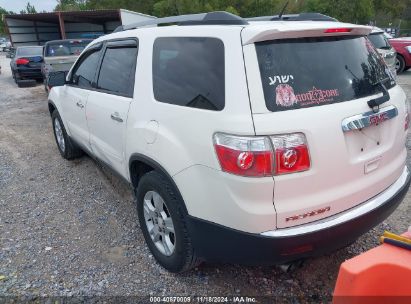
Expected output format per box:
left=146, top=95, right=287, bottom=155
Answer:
left=136, top=171, right=201, bottom=273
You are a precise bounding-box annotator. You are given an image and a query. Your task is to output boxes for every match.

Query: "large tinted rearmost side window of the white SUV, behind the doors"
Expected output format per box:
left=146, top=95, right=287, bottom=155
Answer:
left=153, top=37, right=225, bottom=111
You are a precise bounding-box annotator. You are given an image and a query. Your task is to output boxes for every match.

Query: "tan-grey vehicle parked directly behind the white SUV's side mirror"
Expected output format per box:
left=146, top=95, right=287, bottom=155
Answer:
left=41, top=39, right=93, bottom=91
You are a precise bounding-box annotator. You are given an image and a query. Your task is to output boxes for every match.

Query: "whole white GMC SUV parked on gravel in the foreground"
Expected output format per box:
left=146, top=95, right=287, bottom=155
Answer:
left=48, top=12, right=410, bottom=272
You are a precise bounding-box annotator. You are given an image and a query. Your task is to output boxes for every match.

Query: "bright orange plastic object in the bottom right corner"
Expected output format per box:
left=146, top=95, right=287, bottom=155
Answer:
left=333, top=233, right=411, bottom=304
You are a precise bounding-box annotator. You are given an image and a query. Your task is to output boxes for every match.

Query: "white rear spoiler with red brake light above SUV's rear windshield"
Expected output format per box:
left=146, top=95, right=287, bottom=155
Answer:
left=242, top=22, right=372, bottom=45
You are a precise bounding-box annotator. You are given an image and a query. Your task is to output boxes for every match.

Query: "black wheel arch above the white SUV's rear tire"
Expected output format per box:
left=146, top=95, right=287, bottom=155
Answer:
left=129, top=153, right=188, bottom=215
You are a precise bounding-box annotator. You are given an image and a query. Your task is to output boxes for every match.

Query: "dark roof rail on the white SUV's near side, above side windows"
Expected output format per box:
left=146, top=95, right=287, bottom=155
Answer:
left=114, top=12, right=248, bottom=32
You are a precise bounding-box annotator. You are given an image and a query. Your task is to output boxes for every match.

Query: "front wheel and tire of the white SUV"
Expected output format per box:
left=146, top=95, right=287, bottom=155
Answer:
left=51, top=110, right=83, bottom=160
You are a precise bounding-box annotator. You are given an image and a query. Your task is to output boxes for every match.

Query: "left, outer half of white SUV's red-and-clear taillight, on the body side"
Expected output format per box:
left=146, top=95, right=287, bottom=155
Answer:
left=214, top=133, right=273, bottom=176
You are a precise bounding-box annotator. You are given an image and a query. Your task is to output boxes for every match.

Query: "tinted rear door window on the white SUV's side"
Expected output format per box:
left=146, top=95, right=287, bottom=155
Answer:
left=97, top=47, right=137, bottom=97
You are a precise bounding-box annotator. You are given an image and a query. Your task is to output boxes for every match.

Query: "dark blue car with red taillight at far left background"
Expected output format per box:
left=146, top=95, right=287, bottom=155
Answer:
left=10, top=46, right=43, bottom=84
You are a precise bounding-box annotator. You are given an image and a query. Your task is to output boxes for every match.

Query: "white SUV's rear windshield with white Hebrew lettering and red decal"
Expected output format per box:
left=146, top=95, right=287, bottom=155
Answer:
left=256, top=36, right=395, bottom=112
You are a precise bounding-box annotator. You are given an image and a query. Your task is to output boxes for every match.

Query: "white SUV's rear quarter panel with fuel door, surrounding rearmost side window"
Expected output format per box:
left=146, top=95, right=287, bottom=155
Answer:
left=120, top=26, right=275, bottom=232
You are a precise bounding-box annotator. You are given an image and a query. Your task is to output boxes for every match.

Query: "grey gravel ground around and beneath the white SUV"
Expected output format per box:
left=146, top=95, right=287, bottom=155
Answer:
left=0, top=55, right=411, bottom=303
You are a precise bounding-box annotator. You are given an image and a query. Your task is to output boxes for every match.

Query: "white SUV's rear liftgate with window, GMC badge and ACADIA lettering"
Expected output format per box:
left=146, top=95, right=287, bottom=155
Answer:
left=242, top=23, right=407, bottom=228
